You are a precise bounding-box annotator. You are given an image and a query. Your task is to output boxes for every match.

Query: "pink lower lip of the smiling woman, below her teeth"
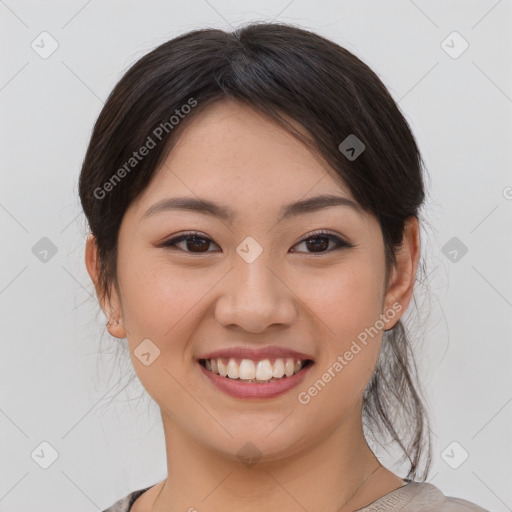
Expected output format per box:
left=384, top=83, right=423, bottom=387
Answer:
left=197, top=362, right=313, bottom=398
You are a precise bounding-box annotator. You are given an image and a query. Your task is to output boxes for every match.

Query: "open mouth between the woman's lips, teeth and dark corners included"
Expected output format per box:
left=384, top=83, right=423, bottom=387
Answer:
left=198, top=357, right=314, bottom=384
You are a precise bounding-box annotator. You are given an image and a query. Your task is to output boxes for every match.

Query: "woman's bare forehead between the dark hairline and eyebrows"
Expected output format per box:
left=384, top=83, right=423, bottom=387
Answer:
left=127, top=100, right=360, bottom=221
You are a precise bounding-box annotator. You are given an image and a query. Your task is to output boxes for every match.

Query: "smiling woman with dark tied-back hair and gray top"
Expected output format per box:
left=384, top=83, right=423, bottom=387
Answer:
left=80, top=23, right=484, bottom=512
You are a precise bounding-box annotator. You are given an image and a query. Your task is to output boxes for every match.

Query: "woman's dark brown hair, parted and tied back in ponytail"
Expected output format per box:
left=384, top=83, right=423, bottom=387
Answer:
left=79, top=22, right=431, bottom=480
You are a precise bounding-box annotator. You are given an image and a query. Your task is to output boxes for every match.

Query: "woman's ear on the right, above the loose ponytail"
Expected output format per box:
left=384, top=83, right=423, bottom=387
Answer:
left=383, top=217, right=421, bottom=331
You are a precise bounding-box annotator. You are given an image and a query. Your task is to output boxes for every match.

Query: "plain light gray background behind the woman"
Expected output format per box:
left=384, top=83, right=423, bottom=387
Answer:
left=0, top=0, right=512, bottom=512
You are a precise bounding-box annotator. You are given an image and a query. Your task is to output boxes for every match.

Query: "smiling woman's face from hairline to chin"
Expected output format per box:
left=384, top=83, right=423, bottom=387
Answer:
left=87, top=101, right=416, bottom=460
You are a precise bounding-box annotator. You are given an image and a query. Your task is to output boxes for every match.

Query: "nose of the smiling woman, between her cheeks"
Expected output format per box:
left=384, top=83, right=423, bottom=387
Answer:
left=215, top=251, right=298, bottom=333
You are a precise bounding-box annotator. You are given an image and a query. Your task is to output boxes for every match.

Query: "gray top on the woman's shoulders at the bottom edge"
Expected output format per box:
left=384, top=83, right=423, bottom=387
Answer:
left=103, top=480, right=489, bottom=512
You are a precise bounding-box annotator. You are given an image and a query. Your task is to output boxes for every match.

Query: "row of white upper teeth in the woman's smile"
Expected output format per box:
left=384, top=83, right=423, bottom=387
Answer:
left=204, top=357, right=304, bottom=382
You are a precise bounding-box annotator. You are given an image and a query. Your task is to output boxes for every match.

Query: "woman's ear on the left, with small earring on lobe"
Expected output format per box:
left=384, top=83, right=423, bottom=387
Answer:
left=85, top=234, right=126, bottom=339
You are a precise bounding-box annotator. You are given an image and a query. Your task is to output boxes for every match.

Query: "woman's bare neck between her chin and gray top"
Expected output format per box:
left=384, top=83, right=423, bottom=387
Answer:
left=148, top=404, right=390, bottom=512
